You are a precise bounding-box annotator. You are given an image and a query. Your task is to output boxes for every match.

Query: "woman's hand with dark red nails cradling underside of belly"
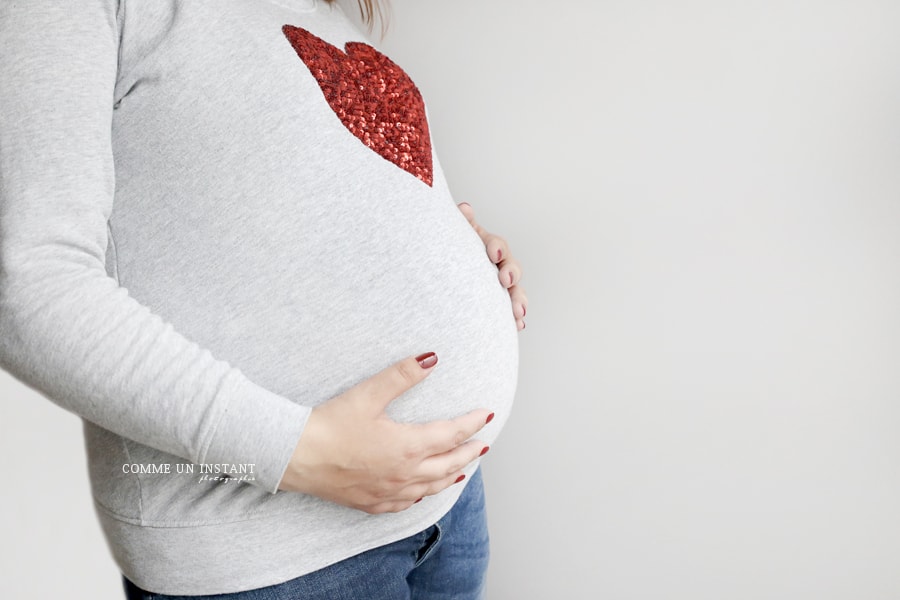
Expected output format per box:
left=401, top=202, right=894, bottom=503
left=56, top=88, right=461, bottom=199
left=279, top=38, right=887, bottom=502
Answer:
left=279, top=352, right=494, bottom=514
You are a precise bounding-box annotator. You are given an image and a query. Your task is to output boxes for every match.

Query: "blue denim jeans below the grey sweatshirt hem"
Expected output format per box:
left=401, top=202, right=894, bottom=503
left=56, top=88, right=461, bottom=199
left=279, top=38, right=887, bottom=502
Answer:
left=122, top=469, right=489, bottom=600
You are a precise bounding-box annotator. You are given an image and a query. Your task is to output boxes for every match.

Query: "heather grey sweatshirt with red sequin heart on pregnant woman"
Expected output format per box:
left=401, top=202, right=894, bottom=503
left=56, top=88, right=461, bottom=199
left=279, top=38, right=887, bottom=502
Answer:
left=0, top=0, right=518, bottom=594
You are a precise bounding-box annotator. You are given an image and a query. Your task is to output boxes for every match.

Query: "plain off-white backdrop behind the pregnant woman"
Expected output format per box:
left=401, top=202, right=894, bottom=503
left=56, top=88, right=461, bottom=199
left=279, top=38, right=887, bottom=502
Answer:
left=0, top=0, right=900, bottom=600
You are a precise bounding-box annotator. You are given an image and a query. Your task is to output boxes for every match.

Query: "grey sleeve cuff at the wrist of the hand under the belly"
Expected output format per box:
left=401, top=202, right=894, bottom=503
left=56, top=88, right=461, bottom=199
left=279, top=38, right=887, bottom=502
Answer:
left=200, top=371, right=312, bottom=494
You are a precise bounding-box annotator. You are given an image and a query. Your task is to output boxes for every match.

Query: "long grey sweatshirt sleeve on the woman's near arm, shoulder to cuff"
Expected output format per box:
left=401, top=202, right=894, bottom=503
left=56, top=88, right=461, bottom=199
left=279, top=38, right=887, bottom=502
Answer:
left=0, top=0, right=309, bottom=493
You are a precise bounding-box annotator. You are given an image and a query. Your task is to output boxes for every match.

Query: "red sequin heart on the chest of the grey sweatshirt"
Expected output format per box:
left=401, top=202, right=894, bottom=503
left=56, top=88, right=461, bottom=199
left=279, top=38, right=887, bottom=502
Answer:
left=282, top=25, right=434, bottom=186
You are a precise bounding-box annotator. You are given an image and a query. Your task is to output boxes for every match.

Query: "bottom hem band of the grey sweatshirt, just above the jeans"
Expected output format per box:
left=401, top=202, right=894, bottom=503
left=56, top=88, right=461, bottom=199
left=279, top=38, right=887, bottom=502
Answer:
left=94, top=474, right=464, bottom=595
